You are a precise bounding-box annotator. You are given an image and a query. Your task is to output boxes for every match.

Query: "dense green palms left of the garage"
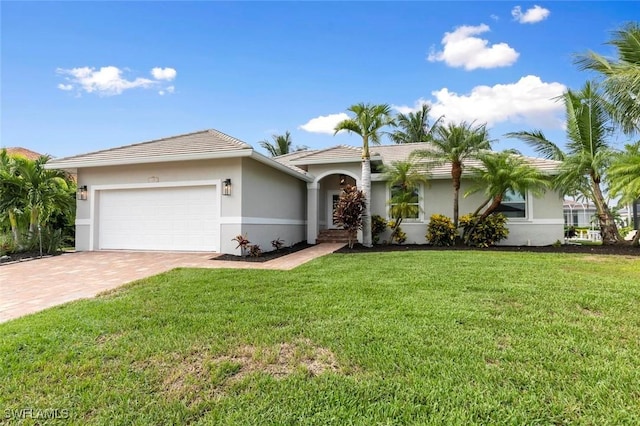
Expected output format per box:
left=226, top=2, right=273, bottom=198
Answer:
left=0, top=149, right=75, bottom=250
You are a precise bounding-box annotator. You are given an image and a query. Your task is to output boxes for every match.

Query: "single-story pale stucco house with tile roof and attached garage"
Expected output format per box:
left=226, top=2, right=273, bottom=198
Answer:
left=47, top=130, right=563, bottom=254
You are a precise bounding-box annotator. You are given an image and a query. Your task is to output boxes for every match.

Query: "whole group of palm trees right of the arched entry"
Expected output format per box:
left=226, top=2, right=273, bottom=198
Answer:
left=334, top=23, right=640, bottom=247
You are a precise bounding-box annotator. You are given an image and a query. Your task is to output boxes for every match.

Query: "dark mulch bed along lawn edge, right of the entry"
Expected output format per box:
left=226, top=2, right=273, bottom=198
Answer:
left=336, top=244, right=640, bottom=256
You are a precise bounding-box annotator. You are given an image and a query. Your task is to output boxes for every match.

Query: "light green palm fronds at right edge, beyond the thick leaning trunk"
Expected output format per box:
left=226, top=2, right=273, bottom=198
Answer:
left=607, top=141, right=640, bottom=245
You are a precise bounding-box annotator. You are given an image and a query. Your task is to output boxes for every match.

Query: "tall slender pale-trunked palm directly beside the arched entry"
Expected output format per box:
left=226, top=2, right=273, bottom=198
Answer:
left=334, top=103, right=393, bottom=247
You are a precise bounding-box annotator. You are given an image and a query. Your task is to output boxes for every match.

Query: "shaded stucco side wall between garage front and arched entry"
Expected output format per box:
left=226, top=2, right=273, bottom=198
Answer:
left=241, top=158, right=307, bottom=254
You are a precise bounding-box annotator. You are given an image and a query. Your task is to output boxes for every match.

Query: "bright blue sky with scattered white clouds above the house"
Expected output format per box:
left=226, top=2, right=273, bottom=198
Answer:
left=0, top=1, right=640, bottom=157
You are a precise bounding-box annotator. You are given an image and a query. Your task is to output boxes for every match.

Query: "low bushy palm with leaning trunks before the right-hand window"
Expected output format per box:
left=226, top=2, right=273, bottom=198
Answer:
left=465, top=151, right=550, bottom=222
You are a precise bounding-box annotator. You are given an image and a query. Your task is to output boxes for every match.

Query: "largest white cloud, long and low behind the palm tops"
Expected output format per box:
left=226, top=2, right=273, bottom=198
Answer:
left=395, top=75, right=566, bottom=129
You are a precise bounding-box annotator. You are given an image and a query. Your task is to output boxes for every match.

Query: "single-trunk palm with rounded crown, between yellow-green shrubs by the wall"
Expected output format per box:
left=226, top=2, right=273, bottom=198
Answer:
left=413, top=122, right=491, bottom=229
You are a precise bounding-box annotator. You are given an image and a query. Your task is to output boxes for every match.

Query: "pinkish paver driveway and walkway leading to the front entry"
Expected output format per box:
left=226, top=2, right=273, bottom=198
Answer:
left=0, top=244, right=344, bottom=322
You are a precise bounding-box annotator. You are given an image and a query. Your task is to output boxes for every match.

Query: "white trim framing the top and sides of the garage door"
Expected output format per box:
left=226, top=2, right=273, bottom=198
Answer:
left=89, top=179, right=222, bottom=251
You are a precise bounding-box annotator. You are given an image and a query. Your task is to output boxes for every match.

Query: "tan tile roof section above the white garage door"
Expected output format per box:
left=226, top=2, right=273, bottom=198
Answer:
left=50, top=129, right=252, bottom=166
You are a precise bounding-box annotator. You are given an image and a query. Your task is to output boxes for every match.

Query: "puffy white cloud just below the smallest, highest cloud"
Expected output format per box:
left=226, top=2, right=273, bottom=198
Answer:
left=427, top=24, right=520, bottom=71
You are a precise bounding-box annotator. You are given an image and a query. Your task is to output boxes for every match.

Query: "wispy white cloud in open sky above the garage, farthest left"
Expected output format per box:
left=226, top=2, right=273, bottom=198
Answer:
left=56, top=66, right=177, bottom=96
